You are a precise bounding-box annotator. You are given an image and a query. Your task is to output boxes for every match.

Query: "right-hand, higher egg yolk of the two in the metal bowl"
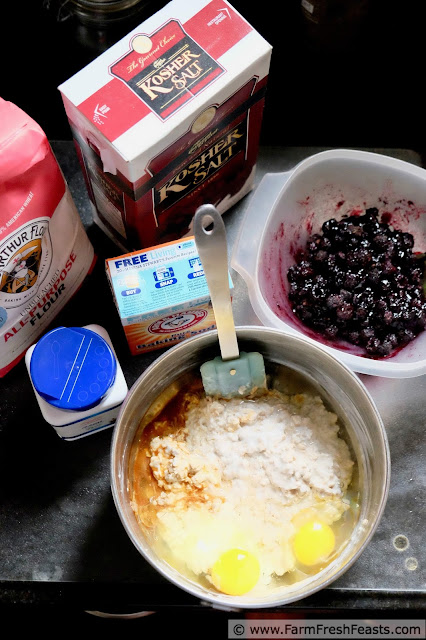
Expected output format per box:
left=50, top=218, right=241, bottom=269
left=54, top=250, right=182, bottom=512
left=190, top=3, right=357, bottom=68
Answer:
left=293, top=520, right=336, bottom=566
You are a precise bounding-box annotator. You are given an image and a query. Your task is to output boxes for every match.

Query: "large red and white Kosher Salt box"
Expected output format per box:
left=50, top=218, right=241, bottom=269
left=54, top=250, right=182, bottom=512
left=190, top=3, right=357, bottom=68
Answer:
left=59, top=0, right=272, bottom=251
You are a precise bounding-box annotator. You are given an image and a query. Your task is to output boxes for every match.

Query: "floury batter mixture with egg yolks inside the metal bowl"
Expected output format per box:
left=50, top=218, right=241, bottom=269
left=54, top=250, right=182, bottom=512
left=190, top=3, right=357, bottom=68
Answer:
left=130, top=381, right=359, bottom=595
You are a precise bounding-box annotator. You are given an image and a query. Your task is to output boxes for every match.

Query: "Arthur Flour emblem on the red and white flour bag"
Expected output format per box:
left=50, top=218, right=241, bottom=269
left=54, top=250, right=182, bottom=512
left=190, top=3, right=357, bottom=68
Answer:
left=0, top=221, right=47, bottom=294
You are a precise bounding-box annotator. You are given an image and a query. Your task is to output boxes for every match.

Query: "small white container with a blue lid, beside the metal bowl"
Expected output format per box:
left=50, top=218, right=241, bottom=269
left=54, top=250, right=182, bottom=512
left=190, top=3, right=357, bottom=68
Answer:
left=25, top=324, right=128, bottom=440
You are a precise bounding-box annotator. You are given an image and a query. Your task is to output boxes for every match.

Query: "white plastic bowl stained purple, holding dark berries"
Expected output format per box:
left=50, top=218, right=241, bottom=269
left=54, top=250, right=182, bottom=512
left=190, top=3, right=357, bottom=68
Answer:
left=231, top=149, right=426, bottom=378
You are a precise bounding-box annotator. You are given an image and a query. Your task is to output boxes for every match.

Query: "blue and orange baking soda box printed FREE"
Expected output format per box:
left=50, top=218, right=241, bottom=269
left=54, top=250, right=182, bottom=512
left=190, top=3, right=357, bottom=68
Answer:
left=105, top=237, right=232, bottom=355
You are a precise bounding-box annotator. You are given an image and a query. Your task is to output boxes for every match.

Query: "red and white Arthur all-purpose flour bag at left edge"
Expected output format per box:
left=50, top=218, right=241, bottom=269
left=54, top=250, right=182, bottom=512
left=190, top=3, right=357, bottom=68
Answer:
left=0, top=98, right=95, bottom=377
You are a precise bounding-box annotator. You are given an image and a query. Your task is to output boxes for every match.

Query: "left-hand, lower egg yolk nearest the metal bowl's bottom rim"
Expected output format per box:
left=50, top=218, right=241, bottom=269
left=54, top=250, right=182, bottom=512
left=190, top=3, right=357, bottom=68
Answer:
left=211, top=549, right=260, bottom=596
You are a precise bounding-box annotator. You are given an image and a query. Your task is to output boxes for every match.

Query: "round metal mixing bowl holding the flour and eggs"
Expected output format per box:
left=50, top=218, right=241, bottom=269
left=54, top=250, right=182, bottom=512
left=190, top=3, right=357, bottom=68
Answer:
left=111, top=327, right=390, bottom=609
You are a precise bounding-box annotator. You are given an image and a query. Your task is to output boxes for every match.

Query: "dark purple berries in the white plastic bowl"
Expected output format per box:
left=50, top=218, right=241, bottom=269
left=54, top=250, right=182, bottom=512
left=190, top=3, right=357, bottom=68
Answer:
left=287, top=207, right=426, bottom=358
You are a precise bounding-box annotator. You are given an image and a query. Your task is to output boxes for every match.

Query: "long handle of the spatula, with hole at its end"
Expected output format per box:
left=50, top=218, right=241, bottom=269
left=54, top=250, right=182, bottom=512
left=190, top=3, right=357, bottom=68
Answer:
left=194, top=204, right=239, bottom=360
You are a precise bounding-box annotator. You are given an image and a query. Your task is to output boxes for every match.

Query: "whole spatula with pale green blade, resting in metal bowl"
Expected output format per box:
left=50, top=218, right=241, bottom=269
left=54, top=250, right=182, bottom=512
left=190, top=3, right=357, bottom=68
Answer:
left=193, top=204, right=266, bottom=398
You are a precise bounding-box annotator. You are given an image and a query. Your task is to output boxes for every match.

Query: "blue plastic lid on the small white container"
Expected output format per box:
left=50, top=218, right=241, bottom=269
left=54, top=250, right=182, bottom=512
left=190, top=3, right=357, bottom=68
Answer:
left=30, top=327, right=117, bottom=411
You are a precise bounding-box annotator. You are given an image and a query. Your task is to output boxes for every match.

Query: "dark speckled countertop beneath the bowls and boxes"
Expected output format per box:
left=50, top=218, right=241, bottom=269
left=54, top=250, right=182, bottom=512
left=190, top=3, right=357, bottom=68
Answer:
left=0, top=141, right=426, bottom=611
